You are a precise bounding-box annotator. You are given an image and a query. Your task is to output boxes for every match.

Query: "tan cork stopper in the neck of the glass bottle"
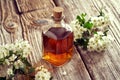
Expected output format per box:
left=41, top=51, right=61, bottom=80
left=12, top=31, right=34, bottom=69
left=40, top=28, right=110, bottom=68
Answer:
left=53, top=7, right=63, bottom=20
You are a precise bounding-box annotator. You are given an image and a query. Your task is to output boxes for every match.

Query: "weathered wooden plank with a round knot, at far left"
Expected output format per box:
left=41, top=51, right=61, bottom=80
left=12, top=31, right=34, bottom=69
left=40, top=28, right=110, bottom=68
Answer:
left=0, top=0, right=22, bottom=44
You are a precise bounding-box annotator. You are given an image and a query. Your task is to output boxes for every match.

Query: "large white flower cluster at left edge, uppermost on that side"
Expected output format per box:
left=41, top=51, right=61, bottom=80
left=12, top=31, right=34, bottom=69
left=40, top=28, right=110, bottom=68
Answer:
left=0, top=40, right=31, bottom=64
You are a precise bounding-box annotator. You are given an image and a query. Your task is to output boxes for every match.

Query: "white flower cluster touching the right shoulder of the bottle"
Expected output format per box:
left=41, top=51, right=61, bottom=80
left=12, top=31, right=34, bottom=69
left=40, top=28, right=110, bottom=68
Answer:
left=70, top=21, right=87, bottom=40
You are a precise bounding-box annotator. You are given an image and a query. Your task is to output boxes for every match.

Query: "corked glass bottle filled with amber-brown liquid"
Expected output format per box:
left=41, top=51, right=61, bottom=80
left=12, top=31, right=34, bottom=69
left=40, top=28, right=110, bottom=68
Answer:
left=43, top=7, right=73, bottom=66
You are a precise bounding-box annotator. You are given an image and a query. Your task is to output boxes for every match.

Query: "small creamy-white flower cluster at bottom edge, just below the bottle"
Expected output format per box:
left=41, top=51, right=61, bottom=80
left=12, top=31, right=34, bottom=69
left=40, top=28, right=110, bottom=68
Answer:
left=35, top=66, right=51, bottom=80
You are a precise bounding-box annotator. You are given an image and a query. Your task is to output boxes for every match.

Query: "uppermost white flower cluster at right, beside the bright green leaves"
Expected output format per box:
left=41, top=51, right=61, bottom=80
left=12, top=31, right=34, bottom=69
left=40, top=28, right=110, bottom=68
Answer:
left=90, top=15, right=110, bottom=29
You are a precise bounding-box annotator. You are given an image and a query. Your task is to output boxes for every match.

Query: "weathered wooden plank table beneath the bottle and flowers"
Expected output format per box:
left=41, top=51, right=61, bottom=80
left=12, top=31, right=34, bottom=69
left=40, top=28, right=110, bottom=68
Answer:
left=0, top=0, right=120, bottom=80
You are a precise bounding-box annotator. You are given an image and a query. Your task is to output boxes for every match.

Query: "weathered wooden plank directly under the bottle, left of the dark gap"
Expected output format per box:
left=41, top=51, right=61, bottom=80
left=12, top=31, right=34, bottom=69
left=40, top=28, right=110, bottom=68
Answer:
left=21, top=2, right=91, bottom=80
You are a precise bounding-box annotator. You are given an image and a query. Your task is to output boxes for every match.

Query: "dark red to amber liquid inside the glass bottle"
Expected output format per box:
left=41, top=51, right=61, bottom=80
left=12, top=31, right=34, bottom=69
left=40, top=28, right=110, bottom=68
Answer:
left=43, top=27, right=73, bottom=66
